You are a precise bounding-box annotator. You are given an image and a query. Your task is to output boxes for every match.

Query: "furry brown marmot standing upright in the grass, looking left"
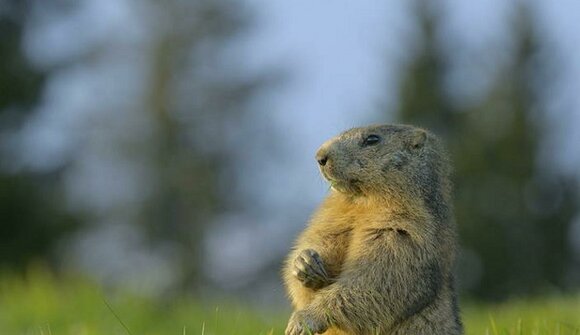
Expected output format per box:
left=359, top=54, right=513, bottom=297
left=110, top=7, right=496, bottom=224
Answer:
left=283, top=125, right=463, bottom=335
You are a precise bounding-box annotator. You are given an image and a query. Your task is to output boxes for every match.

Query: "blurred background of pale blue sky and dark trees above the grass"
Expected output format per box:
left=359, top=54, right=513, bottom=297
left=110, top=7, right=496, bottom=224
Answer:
left=0, top=0, right=580, bottom=308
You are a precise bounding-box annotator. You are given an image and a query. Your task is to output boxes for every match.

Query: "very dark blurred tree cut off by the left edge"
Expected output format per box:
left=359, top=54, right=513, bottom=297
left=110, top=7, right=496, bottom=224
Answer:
left=0, top=0, right=77, bottom=270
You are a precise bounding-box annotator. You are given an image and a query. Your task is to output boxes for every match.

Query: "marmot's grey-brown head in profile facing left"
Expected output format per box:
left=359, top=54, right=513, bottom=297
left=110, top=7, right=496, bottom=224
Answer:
left=316, top=125, right=448, bottom=201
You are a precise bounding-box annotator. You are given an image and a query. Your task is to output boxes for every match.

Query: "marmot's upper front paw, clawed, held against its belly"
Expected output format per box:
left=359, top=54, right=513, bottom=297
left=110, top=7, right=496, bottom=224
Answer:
left=293, top=249, right=331, bottom=289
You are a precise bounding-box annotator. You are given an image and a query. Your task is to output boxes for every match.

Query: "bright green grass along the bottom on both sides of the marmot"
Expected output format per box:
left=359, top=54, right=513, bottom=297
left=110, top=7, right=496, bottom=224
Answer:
left=0, top=271, right=580, bottom=335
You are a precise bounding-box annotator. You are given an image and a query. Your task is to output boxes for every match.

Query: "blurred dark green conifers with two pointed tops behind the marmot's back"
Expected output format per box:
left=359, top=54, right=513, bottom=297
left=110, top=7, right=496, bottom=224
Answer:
left=398, top=2, right=578, bottom=299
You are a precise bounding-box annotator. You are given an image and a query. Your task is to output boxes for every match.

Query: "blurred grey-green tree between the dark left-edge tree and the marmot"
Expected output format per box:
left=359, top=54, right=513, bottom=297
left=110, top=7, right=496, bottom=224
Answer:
left=141, top=0, right=267, bottom=290
